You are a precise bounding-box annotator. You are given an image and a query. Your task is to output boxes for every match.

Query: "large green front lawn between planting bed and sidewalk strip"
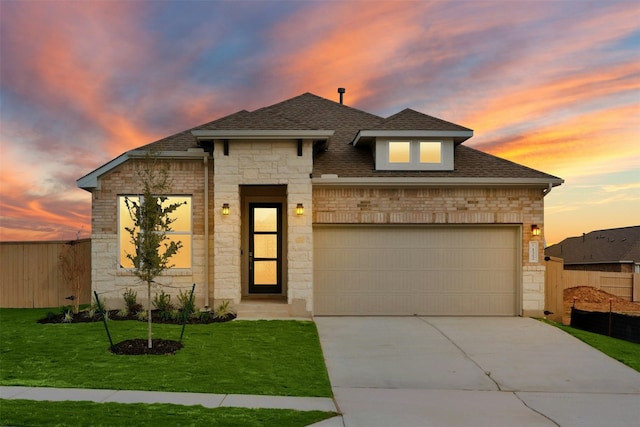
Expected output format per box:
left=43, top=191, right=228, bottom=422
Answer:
left=0, top=309, right=332, bottom=397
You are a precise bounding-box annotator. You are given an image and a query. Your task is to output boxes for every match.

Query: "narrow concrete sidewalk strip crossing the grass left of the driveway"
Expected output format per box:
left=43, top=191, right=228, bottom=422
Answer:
left=0, top=386, right=336, bottom=412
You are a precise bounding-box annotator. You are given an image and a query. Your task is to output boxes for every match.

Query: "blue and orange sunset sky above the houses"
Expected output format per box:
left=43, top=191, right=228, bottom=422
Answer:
left=0, top=0, right=640, bottom=244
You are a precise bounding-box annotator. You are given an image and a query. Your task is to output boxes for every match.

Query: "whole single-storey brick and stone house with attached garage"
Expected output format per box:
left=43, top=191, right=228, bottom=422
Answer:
left=78, top=92, right=563, bottom=316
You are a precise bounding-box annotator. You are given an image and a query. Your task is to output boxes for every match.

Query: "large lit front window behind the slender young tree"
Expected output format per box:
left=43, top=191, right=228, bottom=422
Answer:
left=116, top=194, right=193, bottom=272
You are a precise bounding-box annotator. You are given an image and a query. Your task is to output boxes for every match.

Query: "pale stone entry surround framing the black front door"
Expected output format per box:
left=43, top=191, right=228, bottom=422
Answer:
left=212, top=140, right=313, bottom=312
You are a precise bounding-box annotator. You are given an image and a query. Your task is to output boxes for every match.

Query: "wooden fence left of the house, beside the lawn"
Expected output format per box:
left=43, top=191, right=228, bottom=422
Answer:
left=0, top=239, right=91, bottom=308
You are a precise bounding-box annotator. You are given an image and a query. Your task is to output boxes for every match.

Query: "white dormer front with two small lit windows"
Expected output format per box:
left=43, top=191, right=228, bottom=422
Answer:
left=375, top=139, right=453, bottom=171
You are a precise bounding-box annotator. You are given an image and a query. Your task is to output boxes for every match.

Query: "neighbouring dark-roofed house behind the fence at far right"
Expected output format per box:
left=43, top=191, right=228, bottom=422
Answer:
left=545, top=225, right=640, bottom=273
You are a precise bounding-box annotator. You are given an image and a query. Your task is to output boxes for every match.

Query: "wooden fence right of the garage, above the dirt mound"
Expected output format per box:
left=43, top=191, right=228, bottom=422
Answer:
left=545, top=257, right=640, bottom=322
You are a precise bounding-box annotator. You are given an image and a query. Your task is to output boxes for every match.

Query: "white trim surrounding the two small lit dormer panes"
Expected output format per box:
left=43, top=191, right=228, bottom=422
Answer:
left=375, top=138, right=454, bottom=171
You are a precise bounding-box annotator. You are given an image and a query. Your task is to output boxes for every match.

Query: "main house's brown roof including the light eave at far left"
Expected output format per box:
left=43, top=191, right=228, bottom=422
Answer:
left=78, top=93, right=563, bottom=189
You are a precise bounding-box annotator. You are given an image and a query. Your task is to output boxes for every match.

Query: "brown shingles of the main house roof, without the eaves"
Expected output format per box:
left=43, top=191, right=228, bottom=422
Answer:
left=135, top=93, right=559, bottom=179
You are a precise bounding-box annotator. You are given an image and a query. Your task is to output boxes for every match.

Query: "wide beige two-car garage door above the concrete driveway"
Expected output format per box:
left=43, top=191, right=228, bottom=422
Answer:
left=313, top=226, right=519, bottom=316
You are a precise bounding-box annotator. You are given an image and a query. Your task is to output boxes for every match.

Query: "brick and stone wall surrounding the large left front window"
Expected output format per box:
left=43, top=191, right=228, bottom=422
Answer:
left=91, top=159, right=213, bottom=308
